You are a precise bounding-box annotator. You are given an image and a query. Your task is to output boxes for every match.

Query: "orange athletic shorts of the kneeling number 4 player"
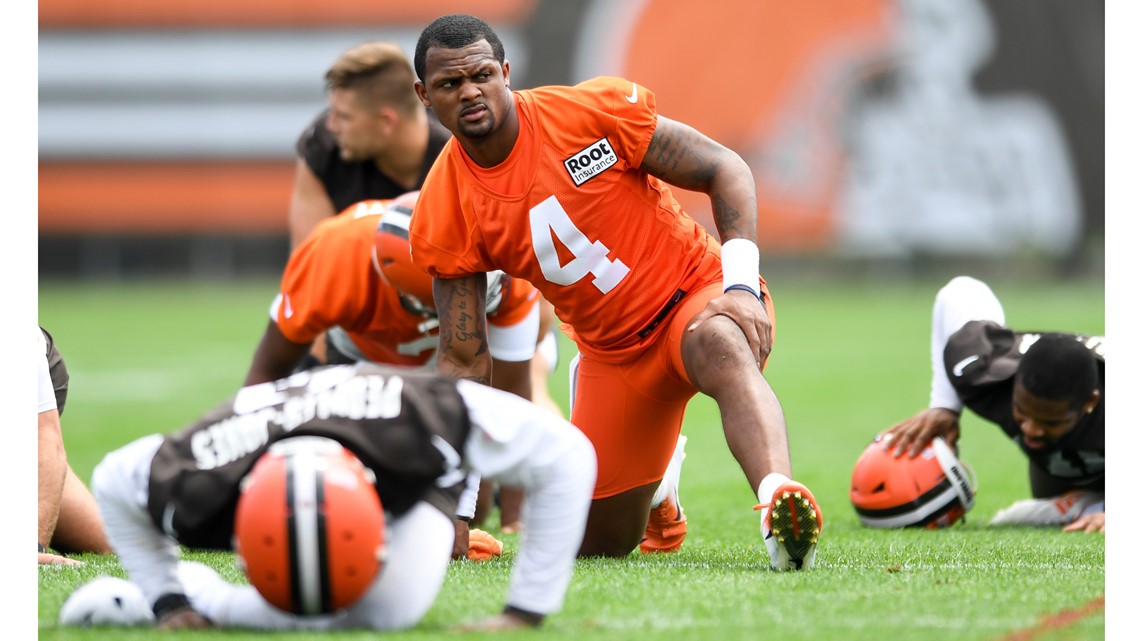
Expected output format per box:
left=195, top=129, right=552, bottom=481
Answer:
left=570, top=278, right=775, bottom=498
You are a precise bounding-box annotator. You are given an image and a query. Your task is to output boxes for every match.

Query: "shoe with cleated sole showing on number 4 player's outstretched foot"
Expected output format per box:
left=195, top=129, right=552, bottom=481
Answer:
left=754, top=480, right=823, bottom=570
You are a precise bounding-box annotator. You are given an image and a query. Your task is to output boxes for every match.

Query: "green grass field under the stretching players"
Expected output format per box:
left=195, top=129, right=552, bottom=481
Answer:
left=38, top=278, right=1106, bottom=641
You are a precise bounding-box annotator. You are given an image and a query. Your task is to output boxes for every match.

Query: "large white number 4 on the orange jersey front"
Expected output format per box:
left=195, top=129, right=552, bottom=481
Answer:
left=530, top=196, right=629, bottom=294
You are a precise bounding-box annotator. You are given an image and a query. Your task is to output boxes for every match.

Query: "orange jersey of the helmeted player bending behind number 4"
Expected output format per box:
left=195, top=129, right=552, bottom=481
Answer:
left=271, top=205, right=537, bottom=366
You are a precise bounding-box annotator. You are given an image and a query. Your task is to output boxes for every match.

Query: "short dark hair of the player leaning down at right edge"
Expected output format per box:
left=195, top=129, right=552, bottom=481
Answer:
left=1015, top=333, right=1100, bottom=407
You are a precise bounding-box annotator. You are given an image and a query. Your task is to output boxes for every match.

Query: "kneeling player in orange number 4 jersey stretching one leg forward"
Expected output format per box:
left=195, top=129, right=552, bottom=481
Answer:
left=410, top=15, right=823, bottom=569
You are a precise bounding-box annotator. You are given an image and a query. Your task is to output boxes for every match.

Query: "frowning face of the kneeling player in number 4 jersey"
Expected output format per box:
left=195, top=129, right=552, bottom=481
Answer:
left=416, top=40, right=513, bottom=143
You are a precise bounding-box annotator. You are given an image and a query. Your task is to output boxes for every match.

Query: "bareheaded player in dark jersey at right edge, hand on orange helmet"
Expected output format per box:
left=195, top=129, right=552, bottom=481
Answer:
left=886, top=276, right=1105, bottom=532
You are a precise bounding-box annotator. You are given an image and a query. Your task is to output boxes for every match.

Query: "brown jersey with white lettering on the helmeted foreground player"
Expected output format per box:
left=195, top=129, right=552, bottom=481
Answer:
left=147, top=364, right=471, bottom=550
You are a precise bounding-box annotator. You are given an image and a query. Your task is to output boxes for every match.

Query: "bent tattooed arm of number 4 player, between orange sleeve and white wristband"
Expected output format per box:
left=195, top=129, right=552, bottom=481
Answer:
left=641, top=115, right=757, bottom=242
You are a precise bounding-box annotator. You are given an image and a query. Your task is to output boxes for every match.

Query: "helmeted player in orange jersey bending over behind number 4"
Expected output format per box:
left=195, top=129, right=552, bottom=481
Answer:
left=245, top=192, right=542, bottom=549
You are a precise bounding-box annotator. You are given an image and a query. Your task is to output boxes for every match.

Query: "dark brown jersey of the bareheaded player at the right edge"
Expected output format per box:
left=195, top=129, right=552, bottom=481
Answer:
left=943, top=321, right=1105, bottom=490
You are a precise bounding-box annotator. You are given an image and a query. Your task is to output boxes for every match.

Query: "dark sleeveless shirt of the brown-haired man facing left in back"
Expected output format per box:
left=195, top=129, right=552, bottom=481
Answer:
left=296, top=109, right=451, bottom=211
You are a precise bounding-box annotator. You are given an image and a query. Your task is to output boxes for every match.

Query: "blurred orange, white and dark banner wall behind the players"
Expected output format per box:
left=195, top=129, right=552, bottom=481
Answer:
left=39, top=0, right=1105, bottom=277
